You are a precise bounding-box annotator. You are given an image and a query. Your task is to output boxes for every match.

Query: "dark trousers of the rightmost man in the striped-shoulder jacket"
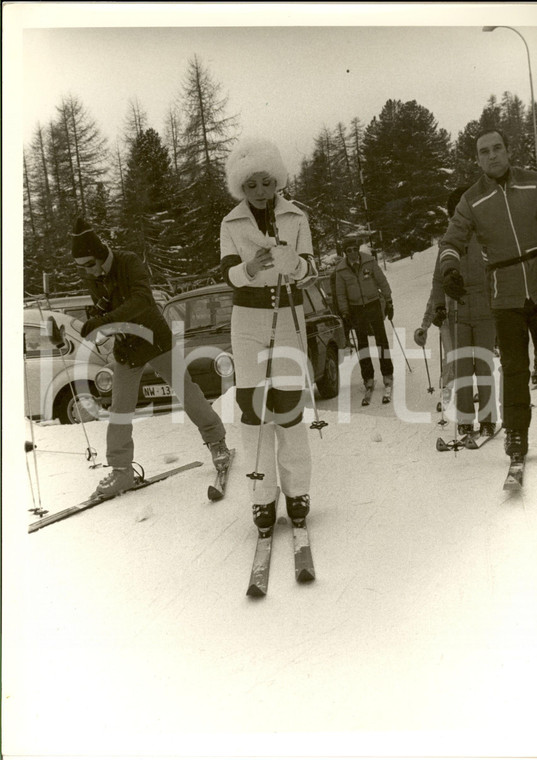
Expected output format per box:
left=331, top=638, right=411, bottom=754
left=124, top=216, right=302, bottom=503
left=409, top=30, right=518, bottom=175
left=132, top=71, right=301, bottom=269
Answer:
left=492, top=300, right=537, bottom=434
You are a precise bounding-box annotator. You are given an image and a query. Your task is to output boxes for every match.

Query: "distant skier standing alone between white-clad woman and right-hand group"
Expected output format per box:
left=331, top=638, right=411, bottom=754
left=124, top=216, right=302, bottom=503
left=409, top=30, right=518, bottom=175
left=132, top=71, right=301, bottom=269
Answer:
left=335, top=235, right=394, bottom=400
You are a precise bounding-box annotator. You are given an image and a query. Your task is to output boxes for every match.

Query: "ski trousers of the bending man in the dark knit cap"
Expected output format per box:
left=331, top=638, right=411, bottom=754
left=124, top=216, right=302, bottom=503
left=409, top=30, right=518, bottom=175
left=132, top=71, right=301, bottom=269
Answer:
left=106, top=347, right=226, bottom=467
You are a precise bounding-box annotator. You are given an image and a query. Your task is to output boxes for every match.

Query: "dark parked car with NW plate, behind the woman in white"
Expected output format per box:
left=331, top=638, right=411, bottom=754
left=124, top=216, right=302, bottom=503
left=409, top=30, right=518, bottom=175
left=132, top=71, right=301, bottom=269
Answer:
left=152, top=283, right=345, bottom=398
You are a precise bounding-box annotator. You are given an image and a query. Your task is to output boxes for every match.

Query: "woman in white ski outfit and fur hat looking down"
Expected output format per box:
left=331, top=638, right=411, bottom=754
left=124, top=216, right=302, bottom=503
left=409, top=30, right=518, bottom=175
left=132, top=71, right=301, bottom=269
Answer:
left=220, top=139, right=316, bottom=534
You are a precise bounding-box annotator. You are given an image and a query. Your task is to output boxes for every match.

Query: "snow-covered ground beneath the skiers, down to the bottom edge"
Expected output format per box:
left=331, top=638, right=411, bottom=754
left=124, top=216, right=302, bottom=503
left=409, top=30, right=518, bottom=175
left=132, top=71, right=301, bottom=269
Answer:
left=3, top=249, right=537, bottom=758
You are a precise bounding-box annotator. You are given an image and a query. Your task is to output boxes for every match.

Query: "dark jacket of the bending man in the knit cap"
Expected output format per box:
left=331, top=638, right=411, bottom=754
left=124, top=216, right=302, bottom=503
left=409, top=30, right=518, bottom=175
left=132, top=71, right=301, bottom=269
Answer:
left=85, top=252, right=173, bottom=367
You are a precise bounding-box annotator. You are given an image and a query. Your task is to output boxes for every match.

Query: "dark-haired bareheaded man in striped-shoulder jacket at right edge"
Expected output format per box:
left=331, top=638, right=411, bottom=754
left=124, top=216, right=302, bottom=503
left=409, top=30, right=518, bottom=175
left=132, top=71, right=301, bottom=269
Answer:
left=439, top=129, right=537, bottom=460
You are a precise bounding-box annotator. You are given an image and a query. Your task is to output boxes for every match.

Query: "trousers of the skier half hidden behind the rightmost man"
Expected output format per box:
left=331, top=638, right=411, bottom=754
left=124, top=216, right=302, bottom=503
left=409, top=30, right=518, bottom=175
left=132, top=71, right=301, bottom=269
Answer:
left=450, top=319, right=496, bottom=424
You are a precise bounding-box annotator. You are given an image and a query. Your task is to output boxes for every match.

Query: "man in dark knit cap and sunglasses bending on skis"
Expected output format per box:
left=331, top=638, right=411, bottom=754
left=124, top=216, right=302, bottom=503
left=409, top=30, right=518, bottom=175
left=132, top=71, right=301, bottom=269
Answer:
left=72, top=219, right=230, bottom=496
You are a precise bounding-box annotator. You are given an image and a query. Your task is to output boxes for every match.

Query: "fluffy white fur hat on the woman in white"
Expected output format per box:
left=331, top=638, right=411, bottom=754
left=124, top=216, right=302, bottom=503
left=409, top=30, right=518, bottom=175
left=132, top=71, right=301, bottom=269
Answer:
left=226, top=138, right=287, bottom=201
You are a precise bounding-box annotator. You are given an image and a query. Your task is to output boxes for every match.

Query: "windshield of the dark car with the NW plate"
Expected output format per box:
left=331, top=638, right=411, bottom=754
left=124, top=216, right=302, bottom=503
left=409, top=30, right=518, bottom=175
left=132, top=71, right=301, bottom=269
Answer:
left=165, top=292, right=233, bottom=334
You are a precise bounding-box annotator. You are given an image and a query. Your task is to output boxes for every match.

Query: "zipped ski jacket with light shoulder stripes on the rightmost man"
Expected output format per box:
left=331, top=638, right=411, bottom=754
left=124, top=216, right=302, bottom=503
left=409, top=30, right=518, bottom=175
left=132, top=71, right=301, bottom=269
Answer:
left=439, top=167, right=537, bottom=309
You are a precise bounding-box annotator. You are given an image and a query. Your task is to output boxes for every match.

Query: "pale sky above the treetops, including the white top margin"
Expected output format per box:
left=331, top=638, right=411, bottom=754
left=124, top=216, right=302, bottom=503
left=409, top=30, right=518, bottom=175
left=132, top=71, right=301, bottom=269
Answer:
left=4, top=3, right=537, bottom=175
